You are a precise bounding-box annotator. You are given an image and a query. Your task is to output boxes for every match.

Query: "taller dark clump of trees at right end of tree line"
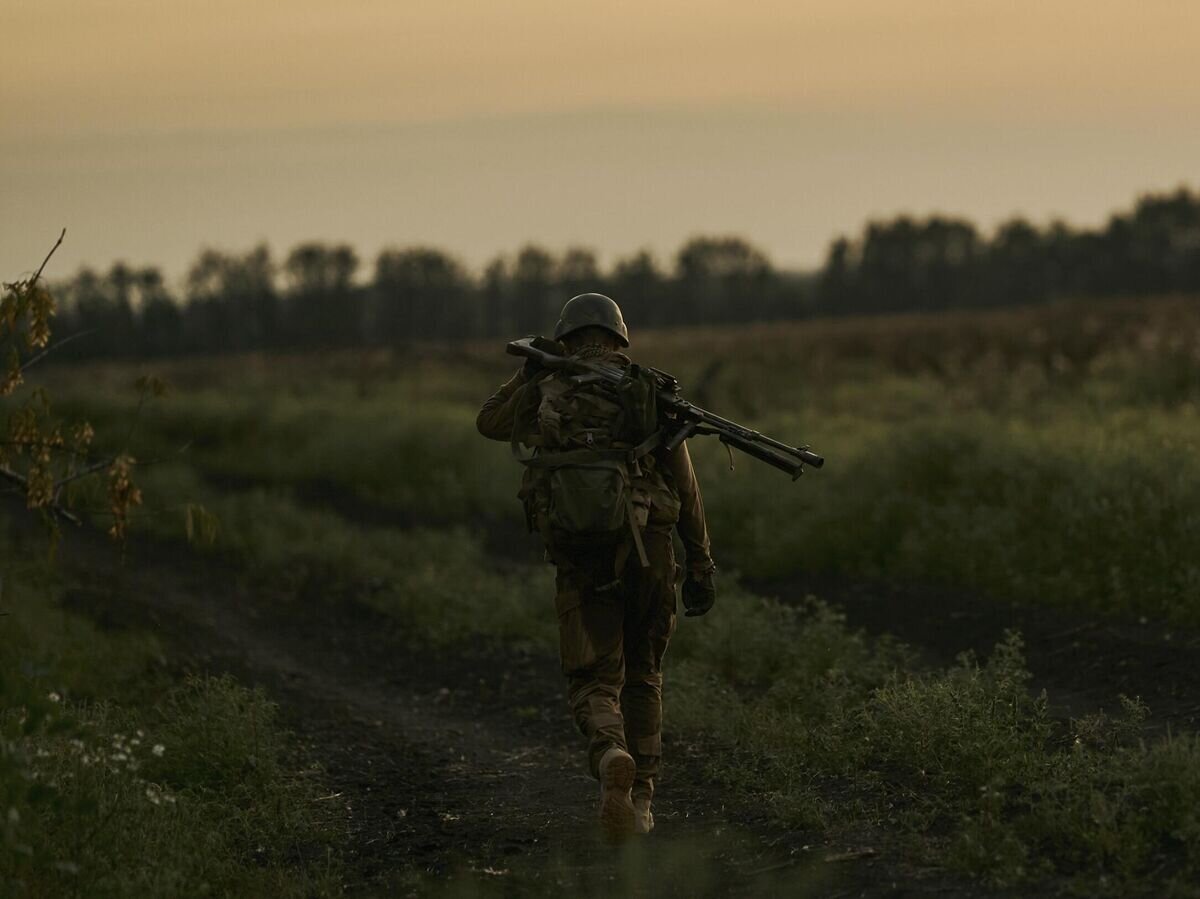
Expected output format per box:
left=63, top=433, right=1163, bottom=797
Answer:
left=811, top=188, right=1200, bottom=314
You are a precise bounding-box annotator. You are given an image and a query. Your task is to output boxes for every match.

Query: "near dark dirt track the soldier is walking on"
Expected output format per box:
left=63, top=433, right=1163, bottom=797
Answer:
left=60, top=539, right=978, bottom=897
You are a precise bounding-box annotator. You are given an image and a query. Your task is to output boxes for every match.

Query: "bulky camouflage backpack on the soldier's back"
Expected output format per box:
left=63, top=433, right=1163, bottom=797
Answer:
left=514, top=353, right=660, bottom=568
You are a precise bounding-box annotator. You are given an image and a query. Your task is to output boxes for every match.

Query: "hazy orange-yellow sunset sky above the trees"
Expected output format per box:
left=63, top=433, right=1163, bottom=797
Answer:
left=0, top=0, right=1200, bottom=280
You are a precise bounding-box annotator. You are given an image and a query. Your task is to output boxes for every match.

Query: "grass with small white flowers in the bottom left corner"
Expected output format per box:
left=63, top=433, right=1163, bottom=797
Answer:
left=0, top=515, right=341, bottom=898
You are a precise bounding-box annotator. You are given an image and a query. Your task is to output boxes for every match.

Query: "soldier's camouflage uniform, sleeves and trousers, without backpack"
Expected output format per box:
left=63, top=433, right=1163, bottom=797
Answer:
left=476, top=371, right=713, bottom=799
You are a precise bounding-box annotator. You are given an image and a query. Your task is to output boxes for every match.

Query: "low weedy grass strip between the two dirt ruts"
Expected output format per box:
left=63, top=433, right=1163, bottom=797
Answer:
left=60, top=458, right=1200, bottom=895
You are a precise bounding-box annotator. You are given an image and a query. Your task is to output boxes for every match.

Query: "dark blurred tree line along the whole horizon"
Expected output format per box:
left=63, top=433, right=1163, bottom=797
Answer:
left=49, top=188, right=1200, bottom=358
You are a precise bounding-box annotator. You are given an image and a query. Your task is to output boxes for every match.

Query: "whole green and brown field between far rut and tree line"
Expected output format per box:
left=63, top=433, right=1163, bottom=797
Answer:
left=58, top=294, right=1200, bottom=625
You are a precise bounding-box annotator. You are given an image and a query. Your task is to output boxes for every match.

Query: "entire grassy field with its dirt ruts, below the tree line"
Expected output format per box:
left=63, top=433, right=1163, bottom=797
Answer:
left=5, top=292, right=1200, bottom=895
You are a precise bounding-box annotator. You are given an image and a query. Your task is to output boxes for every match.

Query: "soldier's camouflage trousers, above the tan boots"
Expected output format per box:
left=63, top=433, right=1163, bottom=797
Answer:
left=553, top=529, right=676, bottom=798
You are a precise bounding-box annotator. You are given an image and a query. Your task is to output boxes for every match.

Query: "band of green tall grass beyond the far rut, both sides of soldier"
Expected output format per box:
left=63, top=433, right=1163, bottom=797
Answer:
left=63, top=364, right=1200, bottom=625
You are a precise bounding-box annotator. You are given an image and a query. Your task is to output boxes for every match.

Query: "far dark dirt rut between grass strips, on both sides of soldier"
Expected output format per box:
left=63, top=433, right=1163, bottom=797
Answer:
left=210, top=477, right=1200, bottom=731
